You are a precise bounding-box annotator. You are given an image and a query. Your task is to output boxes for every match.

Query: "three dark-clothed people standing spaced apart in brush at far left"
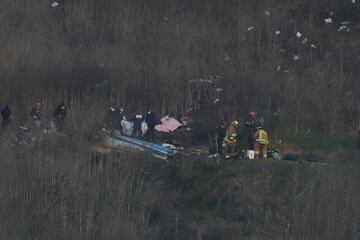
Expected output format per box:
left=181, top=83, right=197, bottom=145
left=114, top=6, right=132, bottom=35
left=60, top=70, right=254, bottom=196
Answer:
left=1, top=102, right=67, bottom=127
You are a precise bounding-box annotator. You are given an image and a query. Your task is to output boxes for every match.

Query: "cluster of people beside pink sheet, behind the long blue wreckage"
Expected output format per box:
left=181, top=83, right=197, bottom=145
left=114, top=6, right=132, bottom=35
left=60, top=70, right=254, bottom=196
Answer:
left=105, top=107, right=156, bottom=138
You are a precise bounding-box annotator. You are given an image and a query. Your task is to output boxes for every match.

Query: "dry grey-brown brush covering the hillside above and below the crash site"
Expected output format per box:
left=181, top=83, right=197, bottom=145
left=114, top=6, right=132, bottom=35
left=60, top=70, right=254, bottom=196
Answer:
left=0, top=0, right=360, bottom=240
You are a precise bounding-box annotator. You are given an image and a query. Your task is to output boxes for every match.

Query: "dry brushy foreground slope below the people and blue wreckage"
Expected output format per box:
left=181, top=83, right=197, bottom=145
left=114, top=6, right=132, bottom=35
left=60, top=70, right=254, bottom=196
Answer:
left=0, top=131, right=360, bottom=240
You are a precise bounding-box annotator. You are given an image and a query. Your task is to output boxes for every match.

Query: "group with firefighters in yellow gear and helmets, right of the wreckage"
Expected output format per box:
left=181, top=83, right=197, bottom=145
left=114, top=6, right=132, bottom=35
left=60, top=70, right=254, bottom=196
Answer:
left=216, top=112, right=269, bottom=159
